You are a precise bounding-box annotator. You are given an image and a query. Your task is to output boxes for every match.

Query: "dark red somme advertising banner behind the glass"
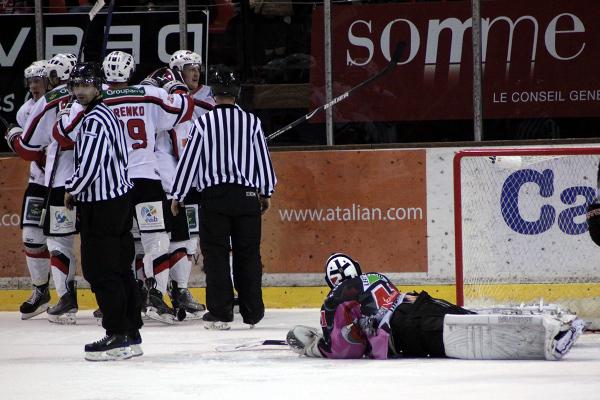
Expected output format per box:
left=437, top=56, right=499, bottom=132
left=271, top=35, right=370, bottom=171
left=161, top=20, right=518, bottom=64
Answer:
left=311, top=0, right=600, bottom=122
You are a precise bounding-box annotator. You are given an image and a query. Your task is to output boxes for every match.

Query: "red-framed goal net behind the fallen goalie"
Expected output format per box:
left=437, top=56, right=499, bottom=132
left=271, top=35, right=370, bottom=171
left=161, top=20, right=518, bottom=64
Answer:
left=454, top=148, right=600, bottom=327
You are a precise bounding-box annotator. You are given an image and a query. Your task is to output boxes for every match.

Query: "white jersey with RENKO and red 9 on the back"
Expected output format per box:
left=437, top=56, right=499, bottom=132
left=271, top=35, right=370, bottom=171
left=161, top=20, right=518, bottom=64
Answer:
left=104, top=85, right=194, bottom=180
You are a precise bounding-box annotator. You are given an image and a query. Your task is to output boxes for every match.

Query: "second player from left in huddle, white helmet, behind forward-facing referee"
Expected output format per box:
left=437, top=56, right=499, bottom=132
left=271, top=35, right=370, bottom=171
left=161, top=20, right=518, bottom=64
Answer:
left=7, top=54, right=78, bottom=324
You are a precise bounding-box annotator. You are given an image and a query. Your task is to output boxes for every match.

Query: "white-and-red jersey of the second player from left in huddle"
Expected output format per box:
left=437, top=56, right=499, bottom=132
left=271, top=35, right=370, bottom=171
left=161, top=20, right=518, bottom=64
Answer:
left=13, top=85, right=74, bottom=187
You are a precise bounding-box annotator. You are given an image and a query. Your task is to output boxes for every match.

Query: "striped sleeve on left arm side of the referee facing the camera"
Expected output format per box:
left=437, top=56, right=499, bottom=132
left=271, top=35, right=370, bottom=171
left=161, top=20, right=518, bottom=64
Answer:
left=65, top=119, right=109, bottom=196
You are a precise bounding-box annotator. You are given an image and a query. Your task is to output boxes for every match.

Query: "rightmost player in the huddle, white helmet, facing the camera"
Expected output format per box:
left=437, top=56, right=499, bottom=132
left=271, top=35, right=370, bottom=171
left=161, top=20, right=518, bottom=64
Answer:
left=156, top=50, right=214, bottom=320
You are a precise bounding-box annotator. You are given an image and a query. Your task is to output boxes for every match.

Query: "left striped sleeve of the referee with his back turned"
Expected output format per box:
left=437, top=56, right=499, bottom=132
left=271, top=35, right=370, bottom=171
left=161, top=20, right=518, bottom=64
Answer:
left=171, top=118, right=204, bottom=201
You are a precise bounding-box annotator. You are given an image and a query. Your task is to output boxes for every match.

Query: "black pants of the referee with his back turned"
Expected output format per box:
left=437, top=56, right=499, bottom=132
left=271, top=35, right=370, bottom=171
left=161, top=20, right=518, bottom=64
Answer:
left=199, top=184, right=265, bottom=324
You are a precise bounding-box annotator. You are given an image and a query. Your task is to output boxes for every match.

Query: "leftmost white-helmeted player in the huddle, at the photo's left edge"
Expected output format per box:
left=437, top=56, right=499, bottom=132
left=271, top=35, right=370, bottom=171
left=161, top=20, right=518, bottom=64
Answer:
left=6, top=60, right=50, bottom=319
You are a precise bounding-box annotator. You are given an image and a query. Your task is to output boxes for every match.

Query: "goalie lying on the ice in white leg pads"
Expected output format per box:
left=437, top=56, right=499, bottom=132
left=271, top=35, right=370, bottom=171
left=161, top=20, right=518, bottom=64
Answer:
left=287, top=253, right=584, bottom=360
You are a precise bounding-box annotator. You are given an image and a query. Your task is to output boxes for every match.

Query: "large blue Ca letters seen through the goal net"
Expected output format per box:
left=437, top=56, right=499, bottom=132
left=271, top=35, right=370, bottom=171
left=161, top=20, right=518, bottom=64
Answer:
left=500, top=169, right=596, bottom=235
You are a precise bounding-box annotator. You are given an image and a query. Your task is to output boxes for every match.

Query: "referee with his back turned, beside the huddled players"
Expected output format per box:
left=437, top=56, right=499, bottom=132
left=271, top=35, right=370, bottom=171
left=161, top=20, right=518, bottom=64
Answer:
left=171, top=65, right=277, bottom=329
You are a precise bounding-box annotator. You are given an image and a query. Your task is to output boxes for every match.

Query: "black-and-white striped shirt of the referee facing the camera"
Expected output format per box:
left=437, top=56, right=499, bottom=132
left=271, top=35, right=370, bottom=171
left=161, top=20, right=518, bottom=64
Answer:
left=65, top=99, right=133, bottom=202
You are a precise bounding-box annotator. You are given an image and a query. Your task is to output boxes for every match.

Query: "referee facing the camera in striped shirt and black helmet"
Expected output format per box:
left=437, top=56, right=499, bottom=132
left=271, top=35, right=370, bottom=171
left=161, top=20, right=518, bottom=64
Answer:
left=65, top=63, right=142, bottom=361
